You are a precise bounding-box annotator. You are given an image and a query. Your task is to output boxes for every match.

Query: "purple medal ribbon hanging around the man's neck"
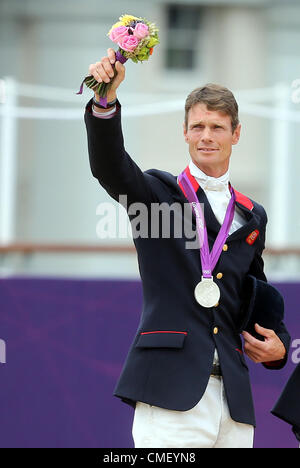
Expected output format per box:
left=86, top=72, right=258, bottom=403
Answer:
left=178, top=171, right=235, bottom=278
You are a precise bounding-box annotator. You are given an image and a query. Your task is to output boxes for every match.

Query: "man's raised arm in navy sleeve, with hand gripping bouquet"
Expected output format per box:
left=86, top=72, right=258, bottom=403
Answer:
left=85, top=49, right=155, bottom=204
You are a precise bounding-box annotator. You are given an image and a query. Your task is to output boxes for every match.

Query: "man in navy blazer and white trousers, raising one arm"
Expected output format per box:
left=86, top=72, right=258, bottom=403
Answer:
left=85, top=49, right=289, bottom=447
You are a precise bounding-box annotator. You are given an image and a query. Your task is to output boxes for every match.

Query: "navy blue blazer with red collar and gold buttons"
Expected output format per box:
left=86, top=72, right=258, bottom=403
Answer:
left=85, top=101, right=289, bottom=425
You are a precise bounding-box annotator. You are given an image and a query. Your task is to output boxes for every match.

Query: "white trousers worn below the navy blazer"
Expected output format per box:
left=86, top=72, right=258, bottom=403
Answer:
left=132, top=376, right=254, bottom=448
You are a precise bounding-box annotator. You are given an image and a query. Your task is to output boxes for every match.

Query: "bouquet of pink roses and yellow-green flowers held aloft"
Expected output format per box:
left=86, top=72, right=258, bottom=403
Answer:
left=77, top=15, right=159, bottom=106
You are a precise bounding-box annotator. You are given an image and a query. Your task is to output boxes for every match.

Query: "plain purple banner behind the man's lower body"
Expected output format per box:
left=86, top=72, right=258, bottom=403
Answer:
left=0, top=278, right=300, bottom=448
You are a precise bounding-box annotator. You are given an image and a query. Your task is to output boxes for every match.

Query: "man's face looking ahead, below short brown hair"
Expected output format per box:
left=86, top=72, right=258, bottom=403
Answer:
left=184, top=103, right=241, bottom=172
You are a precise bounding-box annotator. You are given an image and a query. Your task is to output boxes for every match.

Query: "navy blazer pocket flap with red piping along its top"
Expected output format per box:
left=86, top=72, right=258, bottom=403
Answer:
left=135, top=330, right=187, bottom=348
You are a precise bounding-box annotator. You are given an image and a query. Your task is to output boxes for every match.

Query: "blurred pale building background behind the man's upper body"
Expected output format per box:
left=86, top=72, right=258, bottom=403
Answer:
left=0, top=0, right=300, bottom=280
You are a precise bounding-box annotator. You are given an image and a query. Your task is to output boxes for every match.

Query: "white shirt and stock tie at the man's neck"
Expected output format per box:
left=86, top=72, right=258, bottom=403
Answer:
left=189, top=161, right=246, bottom=235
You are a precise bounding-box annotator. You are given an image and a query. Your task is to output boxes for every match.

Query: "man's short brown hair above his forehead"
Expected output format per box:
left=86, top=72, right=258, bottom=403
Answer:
left=185, top=83, right=239, bottom=133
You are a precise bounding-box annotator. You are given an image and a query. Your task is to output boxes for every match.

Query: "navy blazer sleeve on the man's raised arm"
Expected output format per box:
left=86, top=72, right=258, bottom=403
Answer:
left=84, top=100, right=155, bottom=204
